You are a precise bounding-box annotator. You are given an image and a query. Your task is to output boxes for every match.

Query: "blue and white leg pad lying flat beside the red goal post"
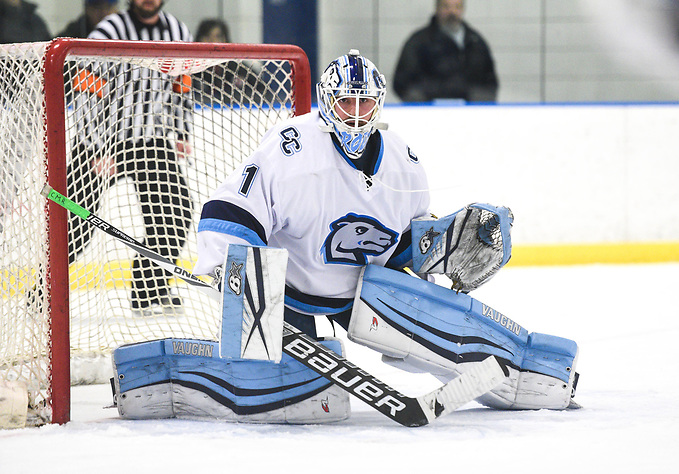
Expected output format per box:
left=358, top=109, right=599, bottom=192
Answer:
left=113, top=338, right=351, bottom=424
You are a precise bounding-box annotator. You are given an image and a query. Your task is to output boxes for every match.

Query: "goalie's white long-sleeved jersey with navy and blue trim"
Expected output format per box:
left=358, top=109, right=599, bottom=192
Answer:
left=195, top=113, right=429, bottom=314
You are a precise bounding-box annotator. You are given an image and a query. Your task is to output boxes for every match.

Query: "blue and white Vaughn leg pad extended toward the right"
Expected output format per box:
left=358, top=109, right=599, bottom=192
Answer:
left=348, top=265, right=578, bottom=409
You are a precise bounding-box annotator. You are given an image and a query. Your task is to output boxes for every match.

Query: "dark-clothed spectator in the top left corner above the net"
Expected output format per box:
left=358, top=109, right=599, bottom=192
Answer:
left=0, top=0, right=52, bottom=43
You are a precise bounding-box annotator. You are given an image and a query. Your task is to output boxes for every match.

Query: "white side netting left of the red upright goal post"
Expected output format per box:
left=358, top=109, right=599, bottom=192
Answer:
left=0, top=44, right=50, bottom=423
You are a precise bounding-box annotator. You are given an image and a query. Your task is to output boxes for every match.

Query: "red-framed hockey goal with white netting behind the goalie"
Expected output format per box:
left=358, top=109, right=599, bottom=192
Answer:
left=0, top=39, right=310, bottom=425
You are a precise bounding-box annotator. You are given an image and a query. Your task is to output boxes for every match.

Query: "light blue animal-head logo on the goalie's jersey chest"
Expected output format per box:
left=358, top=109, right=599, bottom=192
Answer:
left=321, top=213, right=398, bottom=265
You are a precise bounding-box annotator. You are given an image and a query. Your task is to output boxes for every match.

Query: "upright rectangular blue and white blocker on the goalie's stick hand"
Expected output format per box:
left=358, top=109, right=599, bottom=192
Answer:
left=219, top=244, right=288, bottom=362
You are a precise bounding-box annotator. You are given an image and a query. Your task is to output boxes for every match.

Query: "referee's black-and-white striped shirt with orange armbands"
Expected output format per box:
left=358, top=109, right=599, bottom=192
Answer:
left=75, top=11, right=193, bottom=148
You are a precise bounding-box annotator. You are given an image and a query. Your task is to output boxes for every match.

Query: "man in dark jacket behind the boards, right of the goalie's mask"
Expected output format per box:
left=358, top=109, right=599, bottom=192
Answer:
left=394, top=0, right=498, bottom=102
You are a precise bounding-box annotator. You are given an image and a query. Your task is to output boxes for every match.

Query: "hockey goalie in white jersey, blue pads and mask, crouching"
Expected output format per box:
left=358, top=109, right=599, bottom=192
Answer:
left=114, top=50, right=578, bottom=423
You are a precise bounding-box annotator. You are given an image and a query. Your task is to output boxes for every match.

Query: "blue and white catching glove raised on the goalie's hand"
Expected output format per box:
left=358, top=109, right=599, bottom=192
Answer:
left=412, top=203, right=514, bottom=293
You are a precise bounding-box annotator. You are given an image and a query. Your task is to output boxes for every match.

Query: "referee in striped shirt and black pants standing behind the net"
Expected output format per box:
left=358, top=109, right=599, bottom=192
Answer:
left=68, top=0, right=193, bottom=316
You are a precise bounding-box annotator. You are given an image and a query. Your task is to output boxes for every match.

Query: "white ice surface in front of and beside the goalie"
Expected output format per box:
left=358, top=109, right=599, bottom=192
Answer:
left=0, top=263, right=679, bottom=474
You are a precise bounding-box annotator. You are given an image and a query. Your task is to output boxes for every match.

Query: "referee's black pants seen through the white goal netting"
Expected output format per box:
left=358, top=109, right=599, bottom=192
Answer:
left=67, top=139, right=193, bottom=309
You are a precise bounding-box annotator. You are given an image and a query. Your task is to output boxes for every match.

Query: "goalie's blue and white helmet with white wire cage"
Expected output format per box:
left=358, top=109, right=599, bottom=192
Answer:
left=316, top=49, right=387, bottom=159
